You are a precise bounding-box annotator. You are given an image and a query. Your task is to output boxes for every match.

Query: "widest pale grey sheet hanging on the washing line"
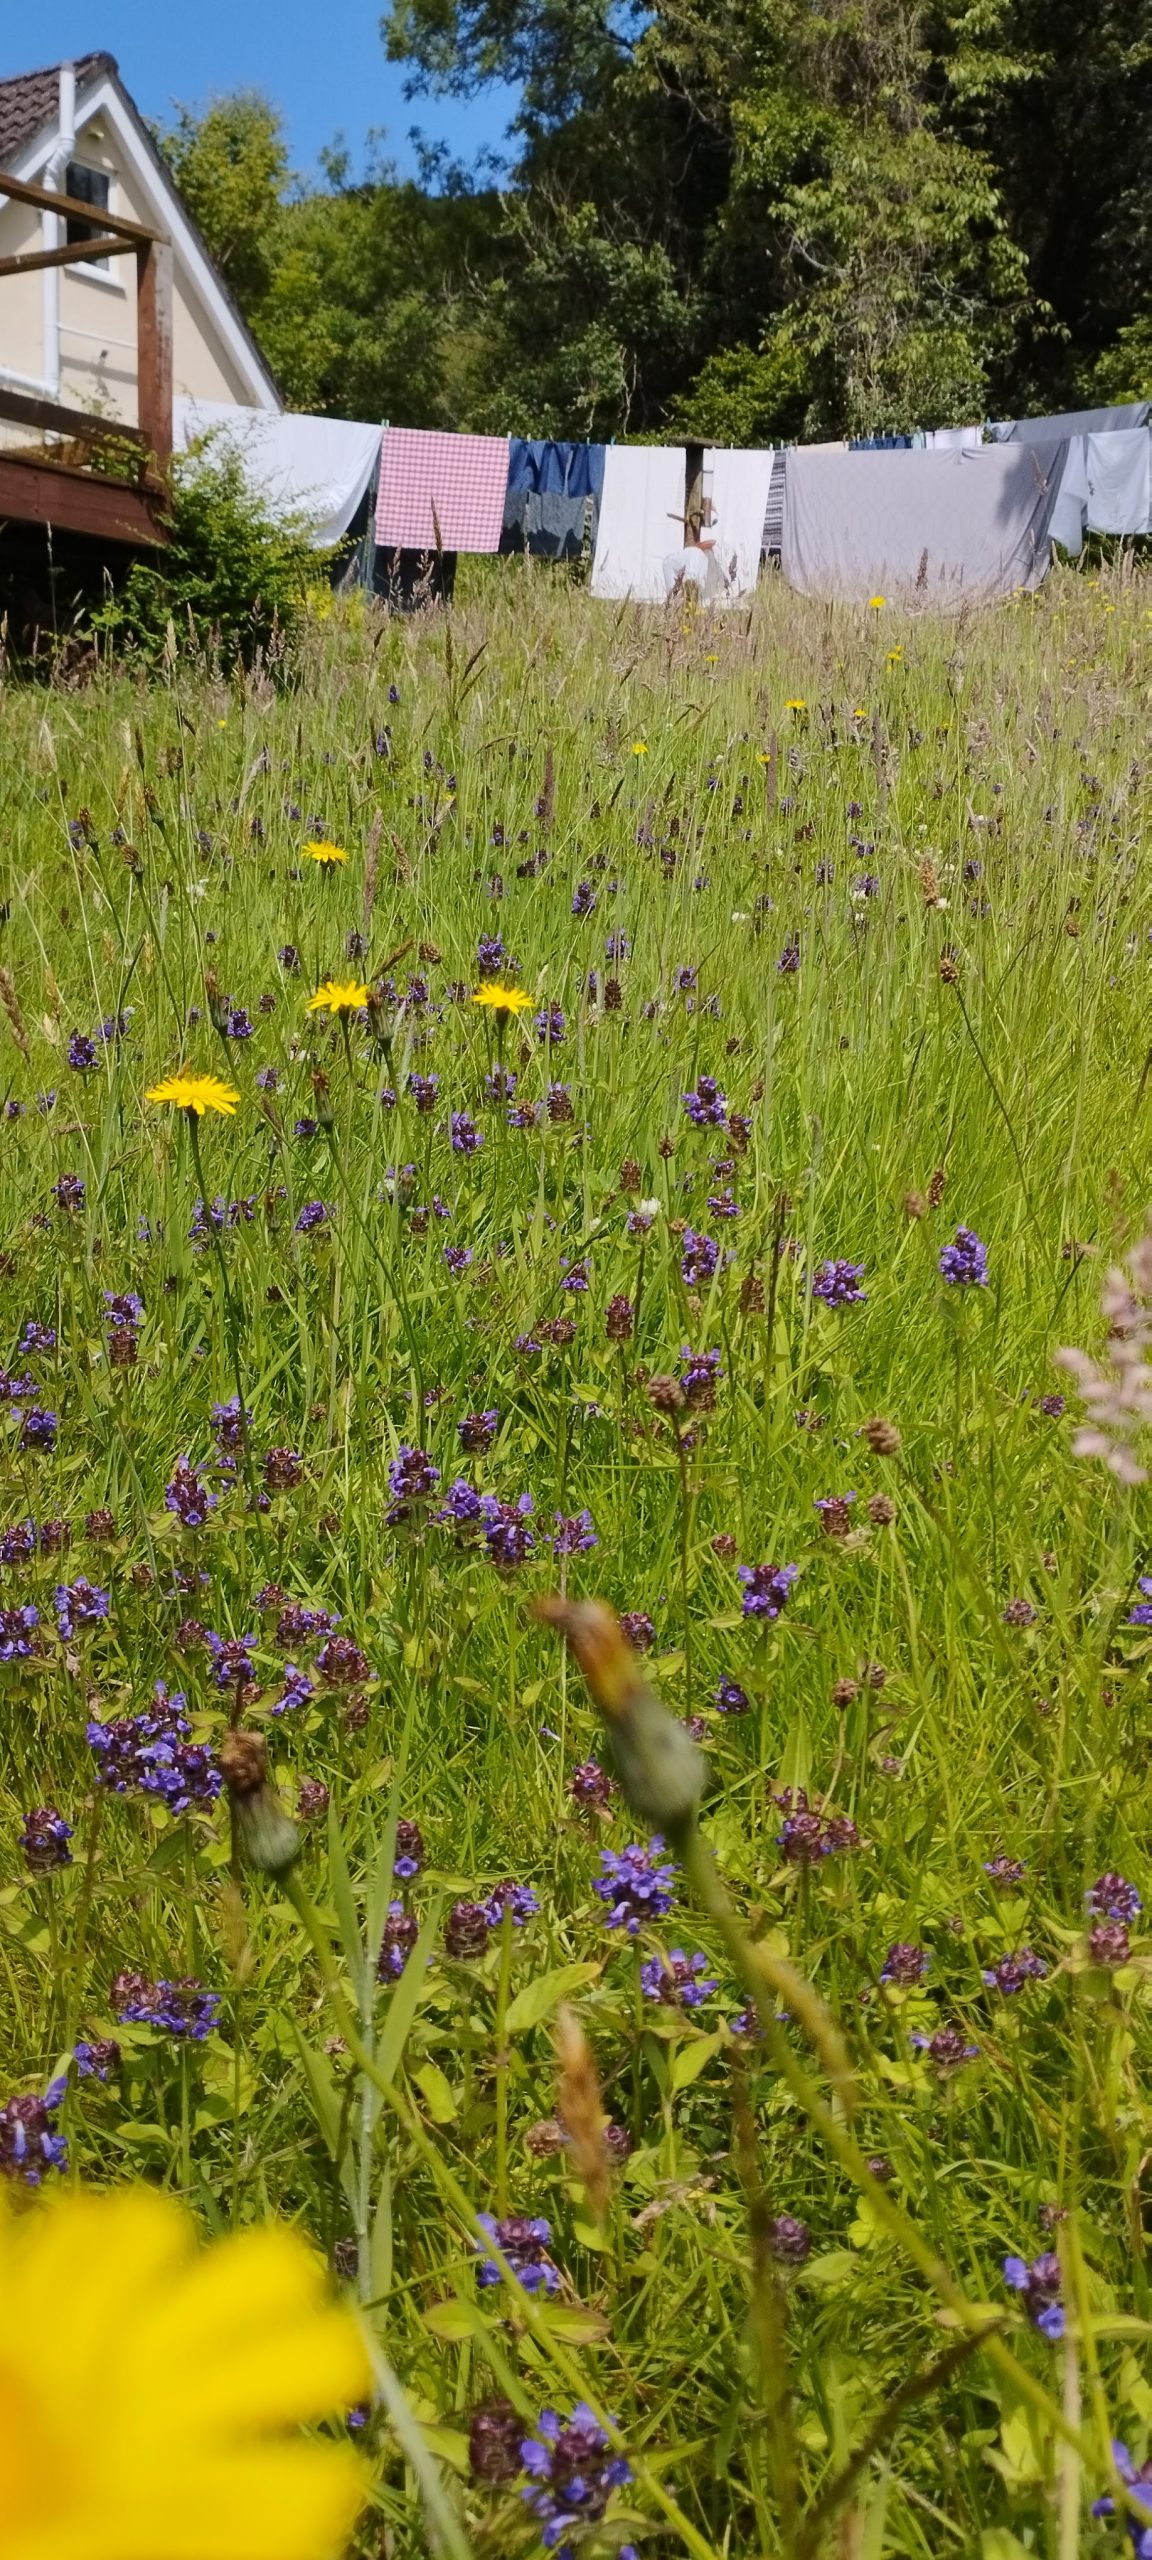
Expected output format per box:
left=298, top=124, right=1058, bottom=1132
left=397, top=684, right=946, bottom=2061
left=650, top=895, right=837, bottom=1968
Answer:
left=781, top=443, right=1068, bottom=612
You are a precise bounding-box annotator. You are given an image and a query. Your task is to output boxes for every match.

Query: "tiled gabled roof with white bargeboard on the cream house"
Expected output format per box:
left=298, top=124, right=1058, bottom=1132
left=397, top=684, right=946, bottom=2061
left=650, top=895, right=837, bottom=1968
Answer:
left=0, top=54, right=282, bottom=412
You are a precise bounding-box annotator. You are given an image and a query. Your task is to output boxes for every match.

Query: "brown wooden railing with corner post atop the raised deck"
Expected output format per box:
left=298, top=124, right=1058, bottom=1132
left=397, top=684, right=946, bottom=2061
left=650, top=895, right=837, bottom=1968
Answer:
left=0, top=169, right=172, bottom=479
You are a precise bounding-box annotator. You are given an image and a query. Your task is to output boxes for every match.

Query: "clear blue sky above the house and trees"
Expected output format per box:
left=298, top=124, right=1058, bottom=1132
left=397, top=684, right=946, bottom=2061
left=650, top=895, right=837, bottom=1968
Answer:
left=0, top=0, right=515, bottom=172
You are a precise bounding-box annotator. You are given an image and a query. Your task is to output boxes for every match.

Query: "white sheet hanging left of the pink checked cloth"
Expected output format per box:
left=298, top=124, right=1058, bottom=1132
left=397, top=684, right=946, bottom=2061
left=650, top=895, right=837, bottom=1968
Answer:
left=172, top=394, right=381, bottom=550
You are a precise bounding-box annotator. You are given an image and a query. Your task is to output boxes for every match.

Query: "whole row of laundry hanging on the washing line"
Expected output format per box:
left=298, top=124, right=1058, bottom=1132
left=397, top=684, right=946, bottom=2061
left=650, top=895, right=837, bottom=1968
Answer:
left=177, top=399, right=1152, bottom=604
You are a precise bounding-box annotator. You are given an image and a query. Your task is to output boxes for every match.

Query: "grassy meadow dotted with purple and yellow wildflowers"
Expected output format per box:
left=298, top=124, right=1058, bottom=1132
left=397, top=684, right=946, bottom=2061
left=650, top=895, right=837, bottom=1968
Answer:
left=0, top=563, right=1152, bottom=2560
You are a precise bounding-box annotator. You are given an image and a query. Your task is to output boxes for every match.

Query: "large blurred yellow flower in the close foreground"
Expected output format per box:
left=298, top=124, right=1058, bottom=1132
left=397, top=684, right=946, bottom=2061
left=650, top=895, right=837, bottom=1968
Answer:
left=0, top=2186, right=371, bottom=2560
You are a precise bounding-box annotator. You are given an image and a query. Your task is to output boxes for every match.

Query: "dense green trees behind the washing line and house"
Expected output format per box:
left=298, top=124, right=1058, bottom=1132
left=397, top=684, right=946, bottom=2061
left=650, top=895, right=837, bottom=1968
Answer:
left=161, top=0, right=1152, bottom=443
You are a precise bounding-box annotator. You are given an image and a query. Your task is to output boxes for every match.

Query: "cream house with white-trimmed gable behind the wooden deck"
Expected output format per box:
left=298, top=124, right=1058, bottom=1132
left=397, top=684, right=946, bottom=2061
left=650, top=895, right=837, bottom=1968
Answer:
left=0, top=54, right=282, bottom=425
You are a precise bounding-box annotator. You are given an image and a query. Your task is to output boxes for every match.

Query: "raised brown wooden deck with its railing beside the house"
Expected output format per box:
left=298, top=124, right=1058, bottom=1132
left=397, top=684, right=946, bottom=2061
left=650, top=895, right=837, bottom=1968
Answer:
left=0, top=169, right=172, bottom=558
